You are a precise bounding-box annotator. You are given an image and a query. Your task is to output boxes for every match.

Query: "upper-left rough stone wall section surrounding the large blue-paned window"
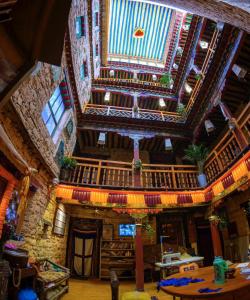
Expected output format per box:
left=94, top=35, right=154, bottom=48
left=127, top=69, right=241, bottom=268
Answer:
left=11, top=64, right=76, bottom=176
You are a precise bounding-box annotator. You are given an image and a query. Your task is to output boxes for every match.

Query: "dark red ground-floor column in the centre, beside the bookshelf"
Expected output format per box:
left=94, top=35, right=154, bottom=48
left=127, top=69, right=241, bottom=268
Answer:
left=135, top=222, right=144, bottom=292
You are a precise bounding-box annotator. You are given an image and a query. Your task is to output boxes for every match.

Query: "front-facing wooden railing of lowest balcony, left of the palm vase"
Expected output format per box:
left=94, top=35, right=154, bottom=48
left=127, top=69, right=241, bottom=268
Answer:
left=65, top=157, right=198, bottom=189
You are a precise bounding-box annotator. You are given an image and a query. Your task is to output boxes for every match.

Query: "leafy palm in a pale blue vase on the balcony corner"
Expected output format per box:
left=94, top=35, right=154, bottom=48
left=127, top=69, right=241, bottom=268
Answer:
left=184, top=144, right=209, bottom=187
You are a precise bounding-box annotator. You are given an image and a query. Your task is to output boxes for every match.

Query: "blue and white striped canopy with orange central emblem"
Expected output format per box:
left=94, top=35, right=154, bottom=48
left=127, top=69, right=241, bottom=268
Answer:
left=108, top=0, right=178, bottom=67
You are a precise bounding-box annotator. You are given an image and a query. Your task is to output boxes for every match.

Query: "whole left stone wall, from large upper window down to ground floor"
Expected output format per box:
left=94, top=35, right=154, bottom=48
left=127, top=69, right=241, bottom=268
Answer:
left=0, top=48, right=76, bottom=264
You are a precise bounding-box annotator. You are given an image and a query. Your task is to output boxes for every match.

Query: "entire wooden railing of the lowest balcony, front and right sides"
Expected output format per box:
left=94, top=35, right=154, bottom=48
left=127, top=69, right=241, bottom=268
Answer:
left=64, top=103, right=250, bottom=190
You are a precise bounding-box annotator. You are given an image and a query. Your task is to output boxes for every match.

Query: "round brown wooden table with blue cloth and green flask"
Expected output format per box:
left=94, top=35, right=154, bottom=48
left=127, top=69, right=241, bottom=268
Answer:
left=161, top=267, right=250, bottom=300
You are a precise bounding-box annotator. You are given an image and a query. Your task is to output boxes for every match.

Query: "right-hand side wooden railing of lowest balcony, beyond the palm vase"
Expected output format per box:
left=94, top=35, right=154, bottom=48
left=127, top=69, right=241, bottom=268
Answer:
left=205, top=103, right=250, bottom=183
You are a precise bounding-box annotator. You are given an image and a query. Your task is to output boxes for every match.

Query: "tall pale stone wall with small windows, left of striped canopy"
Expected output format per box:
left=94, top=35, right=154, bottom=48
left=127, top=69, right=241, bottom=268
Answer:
left=69, top=0, right=92, bottom=110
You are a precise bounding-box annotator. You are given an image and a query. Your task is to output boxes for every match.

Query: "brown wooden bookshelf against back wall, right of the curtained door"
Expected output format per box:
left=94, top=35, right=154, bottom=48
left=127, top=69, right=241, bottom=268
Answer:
left=100, top=240, right=135, bottom=279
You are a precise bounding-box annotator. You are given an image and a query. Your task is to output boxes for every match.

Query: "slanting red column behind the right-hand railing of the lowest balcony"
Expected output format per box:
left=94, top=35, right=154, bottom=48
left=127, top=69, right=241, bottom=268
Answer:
left=218, top=101, right=248, bottom=150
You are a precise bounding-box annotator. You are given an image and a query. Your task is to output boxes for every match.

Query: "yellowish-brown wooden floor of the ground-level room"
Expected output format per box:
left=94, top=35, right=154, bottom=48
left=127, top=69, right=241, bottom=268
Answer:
left=62, top=279, right=173, bottom=300
